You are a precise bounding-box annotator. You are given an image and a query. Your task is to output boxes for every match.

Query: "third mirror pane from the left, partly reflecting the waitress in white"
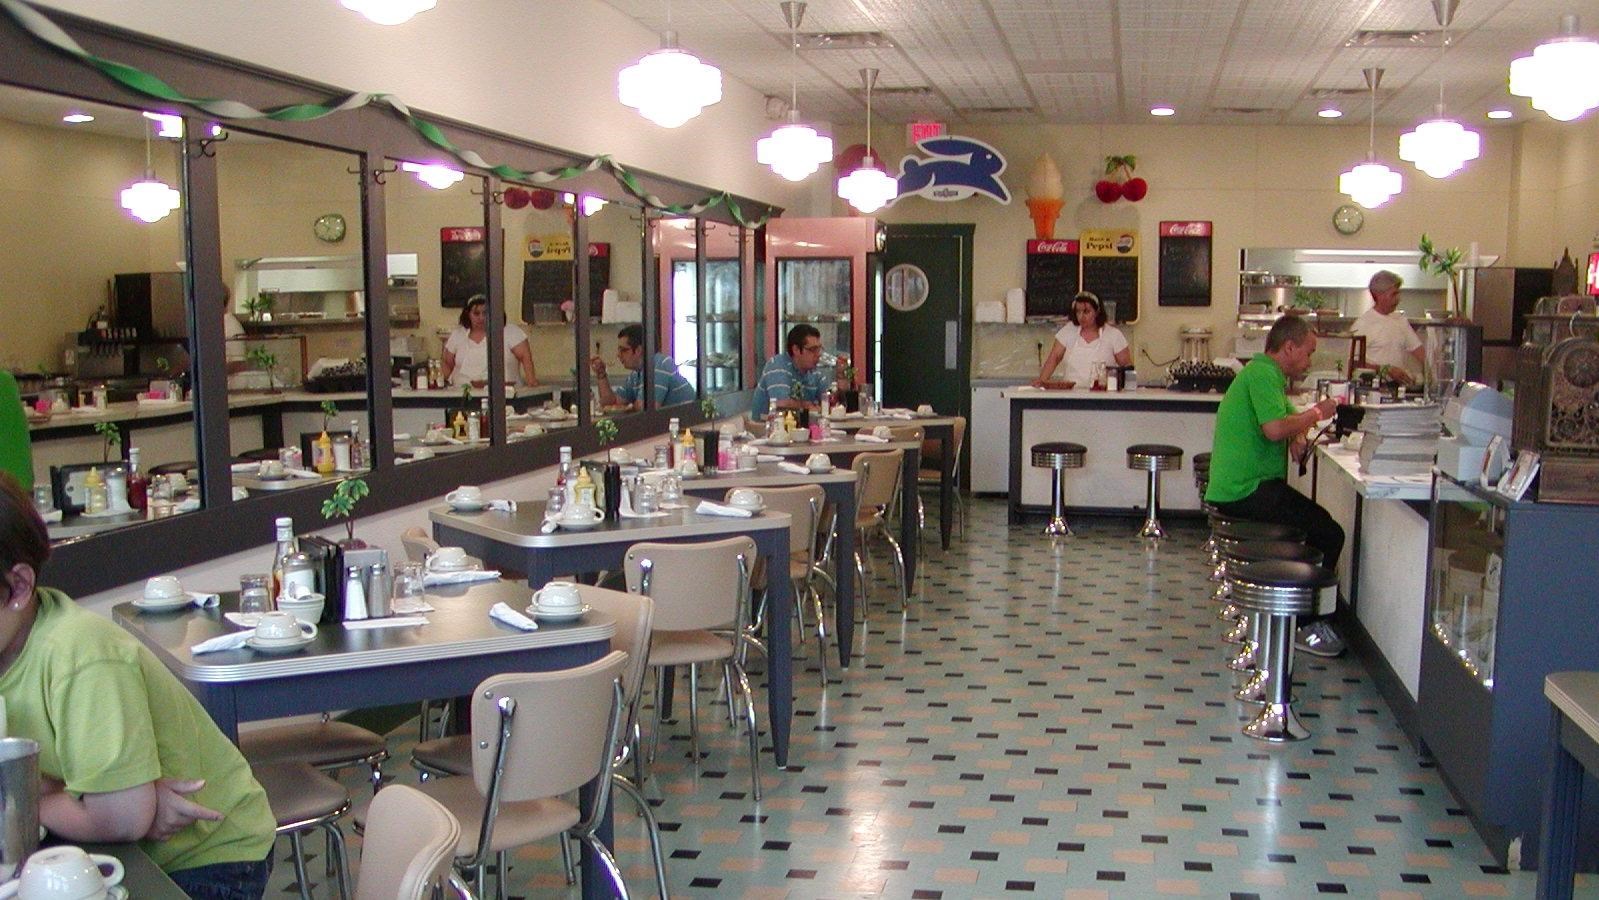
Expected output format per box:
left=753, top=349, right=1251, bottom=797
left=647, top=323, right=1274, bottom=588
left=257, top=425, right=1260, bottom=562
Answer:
left=384, top=160, right=492, bottom=464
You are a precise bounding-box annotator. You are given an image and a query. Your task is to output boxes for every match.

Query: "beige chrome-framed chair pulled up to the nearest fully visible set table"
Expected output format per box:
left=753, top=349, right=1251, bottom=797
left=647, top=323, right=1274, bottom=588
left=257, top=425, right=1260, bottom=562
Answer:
left=394, top=651, right=628, bottom=900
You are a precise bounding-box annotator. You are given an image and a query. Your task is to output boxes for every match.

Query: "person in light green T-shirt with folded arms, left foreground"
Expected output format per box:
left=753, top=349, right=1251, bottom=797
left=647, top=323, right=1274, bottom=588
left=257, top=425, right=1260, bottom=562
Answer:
left=0, top=473, right=277, bottom=900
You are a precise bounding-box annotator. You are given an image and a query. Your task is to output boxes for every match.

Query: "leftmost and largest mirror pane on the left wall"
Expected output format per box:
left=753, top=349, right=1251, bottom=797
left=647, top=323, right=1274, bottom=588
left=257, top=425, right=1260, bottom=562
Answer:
left=0, top=86, right=200, bottom=540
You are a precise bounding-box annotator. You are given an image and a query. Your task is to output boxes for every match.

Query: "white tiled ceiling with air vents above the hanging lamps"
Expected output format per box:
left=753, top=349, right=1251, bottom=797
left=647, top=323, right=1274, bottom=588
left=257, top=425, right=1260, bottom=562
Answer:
left=606, top=0, right=1599, bottom=125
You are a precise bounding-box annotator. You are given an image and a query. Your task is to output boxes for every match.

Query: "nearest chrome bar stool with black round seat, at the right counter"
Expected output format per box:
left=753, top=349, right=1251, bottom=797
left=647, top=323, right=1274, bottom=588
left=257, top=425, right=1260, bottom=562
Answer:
left=1231, top=560, right=1338, bottom=743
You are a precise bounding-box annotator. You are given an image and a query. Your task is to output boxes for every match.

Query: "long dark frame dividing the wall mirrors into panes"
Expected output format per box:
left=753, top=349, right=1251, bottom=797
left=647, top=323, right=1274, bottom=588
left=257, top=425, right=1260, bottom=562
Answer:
left=0, top=10, right=780, bottom=596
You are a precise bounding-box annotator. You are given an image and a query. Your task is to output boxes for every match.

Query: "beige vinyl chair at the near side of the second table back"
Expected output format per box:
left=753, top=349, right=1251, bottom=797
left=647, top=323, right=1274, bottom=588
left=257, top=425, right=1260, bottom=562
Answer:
left=624, top=536, right=761, bottom=801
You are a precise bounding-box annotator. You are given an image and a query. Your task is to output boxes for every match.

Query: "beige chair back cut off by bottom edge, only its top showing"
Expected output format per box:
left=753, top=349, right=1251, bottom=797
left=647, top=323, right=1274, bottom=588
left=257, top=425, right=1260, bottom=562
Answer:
left=355, top=785, right=461, bottom=900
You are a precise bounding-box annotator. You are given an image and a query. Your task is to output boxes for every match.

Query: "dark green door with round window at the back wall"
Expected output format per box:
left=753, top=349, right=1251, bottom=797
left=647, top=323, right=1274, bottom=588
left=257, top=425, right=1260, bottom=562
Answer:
left=873, top=225, right=975, bottom=416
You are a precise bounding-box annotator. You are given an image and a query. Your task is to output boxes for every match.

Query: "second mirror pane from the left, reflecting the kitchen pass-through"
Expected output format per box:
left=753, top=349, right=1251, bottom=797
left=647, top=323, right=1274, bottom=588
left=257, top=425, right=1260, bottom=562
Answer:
left=213, top=129, right=369, bottom=497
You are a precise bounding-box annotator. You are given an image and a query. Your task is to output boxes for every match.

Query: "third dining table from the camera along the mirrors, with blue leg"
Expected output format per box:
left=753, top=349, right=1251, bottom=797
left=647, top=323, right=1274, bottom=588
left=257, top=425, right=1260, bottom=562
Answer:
left=683, top=462, right=859, bottom=668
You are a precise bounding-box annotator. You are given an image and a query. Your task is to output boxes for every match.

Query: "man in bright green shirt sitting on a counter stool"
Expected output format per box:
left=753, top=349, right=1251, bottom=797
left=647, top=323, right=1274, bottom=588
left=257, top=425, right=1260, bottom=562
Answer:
left=1204, top=315, right=1343, bottom=657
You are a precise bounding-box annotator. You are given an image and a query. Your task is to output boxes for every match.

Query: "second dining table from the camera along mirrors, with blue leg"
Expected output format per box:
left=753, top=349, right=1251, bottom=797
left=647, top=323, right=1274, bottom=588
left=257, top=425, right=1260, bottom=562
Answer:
left=427, top=500, right=793, bottom=769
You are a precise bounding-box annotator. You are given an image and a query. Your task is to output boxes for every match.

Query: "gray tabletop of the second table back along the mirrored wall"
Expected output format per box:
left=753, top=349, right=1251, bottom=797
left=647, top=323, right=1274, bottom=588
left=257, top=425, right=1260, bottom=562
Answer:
left=427, top=498, right=788, bottom=550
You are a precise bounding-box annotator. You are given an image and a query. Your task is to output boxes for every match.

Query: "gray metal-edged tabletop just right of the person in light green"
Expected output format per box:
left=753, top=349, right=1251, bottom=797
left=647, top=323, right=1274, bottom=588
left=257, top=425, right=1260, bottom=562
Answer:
left=112, top=578, right=610, bottom=683
